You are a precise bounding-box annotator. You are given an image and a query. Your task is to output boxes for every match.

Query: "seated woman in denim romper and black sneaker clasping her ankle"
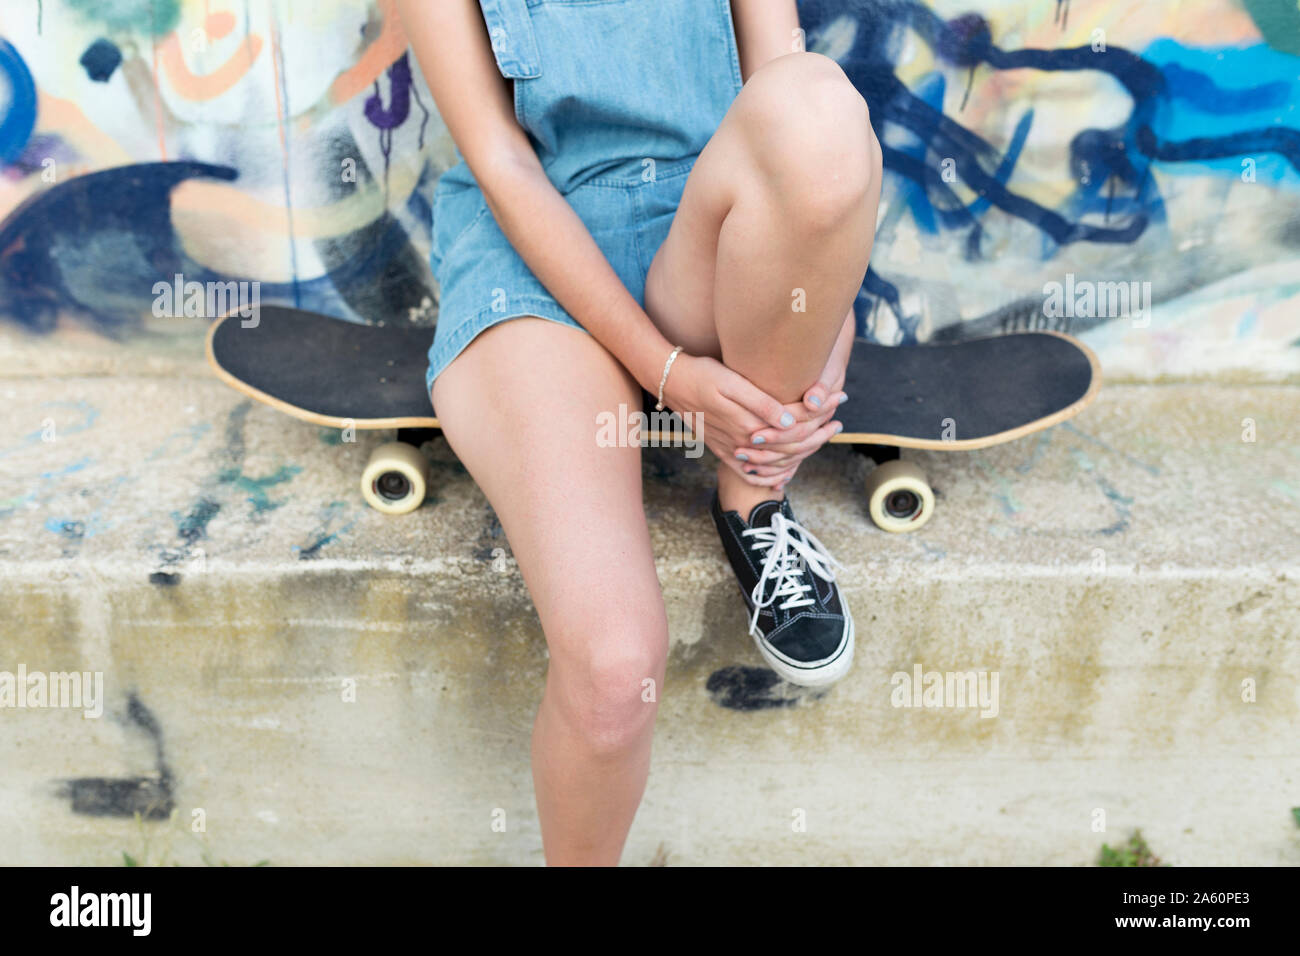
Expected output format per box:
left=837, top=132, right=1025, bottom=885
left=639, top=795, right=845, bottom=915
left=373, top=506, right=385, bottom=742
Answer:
left=398, top=0, right=880, bottom=864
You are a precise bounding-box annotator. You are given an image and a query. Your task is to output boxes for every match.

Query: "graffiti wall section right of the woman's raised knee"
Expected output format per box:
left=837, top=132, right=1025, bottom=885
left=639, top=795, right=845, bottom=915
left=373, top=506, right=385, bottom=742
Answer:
left=801, top=0, right=1300, bottom=377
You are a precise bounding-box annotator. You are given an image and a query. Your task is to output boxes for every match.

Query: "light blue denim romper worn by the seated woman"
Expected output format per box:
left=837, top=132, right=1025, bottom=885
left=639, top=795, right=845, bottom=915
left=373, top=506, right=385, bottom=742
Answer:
left=425, top=0, right=741, bottom=388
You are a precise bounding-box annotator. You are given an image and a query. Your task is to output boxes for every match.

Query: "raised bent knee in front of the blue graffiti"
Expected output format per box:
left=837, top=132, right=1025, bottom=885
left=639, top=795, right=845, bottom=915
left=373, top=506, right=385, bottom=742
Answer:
left=742, top=53, right=880, bottom=229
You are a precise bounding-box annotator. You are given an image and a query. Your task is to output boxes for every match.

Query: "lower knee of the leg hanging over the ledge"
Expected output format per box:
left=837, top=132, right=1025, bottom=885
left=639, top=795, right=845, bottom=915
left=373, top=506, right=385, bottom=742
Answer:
left=546, top=615, right=668, bottom=757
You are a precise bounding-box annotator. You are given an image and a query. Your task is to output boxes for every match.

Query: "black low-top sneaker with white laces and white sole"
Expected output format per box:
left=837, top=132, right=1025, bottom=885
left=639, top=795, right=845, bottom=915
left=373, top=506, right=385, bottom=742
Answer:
left=712, top=492, right=853, bottom=687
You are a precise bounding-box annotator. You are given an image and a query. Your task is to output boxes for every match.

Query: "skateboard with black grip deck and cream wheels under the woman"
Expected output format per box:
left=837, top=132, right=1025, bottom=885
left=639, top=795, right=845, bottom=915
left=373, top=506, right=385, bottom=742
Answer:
left=207, top=306, right=1101, bottom=532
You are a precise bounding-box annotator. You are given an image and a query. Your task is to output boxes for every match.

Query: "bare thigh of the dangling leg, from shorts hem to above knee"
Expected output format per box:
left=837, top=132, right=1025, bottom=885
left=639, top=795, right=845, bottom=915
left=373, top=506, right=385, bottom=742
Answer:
left=433, top=317, right=667, bottom=692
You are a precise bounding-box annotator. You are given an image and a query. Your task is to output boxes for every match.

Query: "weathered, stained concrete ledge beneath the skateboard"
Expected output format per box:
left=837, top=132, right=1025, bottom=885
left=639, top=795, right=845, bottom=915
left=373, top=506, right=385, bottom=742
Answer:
left=0, top=377, right=1300, bottom=865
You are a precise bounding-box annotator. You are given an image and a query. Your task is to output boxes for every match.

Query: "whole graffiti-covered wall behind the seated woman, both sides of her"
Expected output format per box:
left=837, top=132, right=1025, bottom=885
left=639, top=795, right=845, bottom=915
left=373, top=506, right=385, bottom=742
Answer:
left=0, top=0, right=1300, bottom=377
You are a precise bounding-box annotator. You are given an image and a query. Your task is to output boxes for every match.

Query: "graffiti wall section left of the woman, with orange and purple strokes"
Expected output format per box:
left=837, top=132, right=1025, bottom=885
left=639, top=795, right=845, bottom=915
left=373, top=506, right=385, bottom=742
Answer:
left=0, top=0, right=441, bottom=336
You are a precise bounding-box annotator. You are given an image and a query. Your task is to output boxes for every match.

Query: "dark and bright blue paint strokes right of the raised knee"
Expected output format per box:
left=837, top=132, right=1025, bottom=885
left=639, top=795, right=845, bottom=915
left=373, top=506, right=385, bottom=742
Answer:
left=800, top=0, right=1300, bottom=342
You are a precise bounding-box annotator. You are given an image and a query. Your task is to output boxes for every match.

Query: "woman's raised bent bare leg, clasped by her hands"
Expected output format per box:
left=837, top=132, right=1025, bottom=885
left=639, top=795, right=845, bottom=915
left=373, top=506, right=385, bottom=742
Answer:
left=646, top=53, right=880, bottom=514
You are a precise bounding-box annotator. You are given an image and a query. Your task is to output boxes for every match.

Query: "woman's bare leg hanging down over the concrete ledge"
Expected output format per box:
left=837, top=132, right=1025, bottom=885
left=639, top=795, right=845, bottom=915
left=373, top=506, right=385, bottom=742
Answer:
left=433, top=319, right=668, bottom=865
